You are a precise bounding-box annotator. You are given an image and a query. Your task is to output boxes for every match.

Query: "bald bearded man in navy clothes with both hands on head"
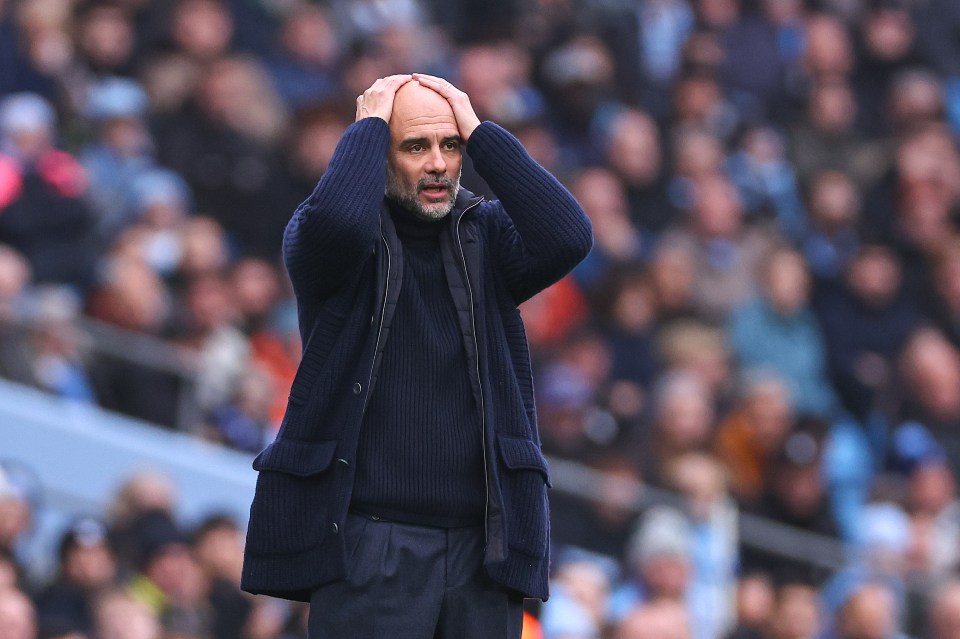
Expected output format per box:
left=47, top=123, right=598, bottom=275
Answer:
left=242, top=74, right=592, bottom=639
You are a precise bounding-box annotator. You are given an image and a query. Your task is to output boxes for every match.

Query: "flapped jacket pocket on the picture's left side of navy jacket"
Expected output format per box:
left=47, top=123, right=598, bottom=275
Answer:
left=247, top=439, right=337, bottom=554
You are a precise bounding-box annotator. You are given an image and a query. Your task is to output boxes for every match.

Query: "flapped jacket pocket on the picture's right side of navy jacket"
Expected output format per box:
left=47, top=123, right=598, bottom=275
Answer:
left=497, top=435, right=550, bottom=558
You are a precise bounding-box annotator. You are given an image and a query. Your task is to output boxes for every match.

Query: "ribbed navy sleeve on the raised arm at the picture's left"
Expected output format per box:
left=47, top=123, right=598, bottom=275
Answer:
left=283, top=118, right=390, bottom=299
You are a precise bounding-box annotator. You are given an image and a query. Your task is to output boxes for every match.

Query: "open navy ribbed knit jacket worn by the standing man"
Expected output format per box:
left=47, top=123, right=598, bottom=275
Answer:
left=241, top=118, right=592, bottom=601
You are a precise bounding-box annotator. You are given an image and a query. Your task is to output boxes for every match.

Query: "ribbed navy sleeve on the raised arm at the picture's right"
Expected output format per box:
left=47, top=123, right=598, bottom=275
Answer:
left=467, top=122, right=593, bottom=303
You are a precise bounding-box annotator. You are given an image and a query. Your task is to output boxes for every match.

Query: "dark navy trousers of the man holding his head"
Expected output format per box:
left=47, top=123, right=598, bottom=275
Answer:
left=309, top=513, right=523, bottom=639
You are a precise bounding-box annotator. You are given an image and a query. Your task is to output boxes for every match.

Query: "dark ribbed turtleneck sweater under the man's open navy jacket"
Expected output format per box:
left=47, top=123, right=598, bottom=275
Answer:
left=352, top=204, right=486, bottom=527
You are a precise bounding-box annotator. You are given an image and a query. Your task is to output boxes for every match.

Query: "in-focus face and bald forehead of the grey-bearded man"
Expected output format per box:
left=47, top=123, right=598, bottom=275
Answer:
left=387, top=82, right=462, bottom=220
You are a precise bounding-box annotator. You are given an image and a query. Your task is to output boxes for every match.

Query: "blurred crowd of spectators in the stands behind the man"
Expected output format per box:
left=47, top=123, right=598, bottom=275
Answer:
left=0, top=0, right=960, bottom=639
